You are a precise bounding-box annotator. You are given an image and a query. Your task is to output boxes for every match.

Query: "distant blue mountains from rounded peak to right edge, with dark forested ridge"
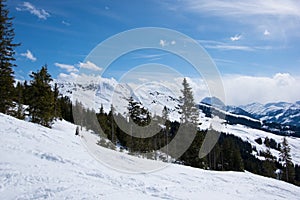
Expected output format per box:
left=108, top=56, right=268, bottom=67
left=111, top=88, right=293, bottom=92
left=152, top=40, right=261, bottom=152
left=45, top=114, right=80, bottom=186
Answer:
left=199, top=97, right=300, bottom=137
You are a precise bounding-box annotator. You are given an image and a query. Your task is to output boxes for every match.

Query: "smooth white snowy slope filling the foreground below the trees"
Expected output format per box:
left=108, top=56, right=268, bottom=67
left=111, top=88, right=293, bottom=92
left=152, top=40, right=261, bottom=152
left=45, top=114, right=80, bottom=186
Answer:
left=0, top=114, right=300, bottom=200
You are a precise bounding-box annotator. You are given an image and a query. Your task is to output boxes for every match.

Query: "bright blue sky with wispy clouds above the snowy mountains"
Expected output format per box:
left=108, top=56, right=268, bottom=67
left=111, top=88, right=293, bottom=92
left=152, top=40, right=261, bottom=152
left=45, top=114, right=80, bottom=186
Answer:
left=7, top=0, right=300, bottom=104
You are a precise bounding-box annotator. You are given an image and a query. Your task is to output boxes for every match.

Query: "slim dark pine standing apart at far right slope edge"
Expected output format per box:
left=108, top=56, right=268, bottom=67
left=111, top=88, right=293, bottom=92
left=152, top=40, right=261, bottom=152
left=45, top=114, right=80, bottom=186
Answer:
left=280, top=137, right=294, bottom=182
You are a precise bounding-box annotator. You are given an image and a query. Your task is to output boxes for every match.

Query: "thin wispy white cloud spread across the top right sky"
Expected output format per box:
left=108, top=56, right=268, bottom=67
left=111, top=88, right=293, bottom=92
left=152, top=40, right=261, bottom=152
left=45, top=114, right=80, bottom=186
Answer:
left=172, top=0, right=300, bottom=39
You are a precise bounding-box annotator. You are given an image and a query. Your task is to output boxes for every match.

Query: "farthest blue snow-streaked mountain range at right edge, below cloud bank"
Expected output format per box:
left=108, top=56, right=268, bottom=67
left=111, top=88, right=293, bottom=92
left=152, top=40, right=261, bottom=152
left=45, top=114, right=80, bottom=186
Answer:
left=240, top=101, right=300, bottom=127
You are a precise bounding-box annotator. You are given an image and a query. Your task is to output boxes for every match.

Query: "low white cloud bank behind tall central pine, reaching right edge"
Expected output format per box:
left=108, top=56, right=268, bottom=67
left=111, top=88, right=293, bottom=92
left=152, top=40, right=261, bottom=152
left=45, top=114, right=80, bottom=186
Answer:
left=164, top=73, right=300, bottom=106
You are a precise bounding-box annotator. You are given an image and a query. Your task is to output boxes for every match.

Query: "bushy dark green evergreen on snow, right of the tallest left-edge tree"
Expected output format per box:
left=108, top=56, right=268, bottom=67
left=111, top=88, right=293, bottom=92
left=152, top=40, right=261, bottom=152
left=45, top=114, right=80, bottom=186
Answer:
left=29, top=66, right=55, bottom=127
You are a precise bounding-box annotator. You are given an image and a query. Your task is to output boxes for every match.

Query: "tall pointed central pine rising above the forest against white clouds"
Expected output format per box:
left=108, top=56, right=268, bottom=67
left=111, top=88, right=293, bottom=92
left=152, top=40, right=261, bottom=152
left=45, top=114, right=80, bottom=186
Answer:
left=180, top=78, right=199, bottom=124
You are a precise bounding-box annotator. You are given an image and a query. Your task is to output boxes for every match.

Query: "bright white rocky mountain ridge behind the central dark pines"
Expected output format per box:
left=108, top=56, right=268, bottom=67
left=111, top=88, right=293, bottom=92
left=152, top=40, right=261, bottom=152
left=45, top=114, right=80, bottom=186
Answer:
left=56, top=75, right=183, bottom=120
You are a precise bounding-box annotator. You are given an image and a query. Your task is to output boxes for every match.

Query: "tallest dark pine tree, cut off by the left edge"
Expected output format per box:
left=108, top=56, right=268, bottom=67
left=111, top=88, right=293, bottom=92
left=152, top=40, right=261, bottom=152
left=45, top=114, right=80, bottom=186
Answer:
left=0, top=0, right=19, bottom=114
